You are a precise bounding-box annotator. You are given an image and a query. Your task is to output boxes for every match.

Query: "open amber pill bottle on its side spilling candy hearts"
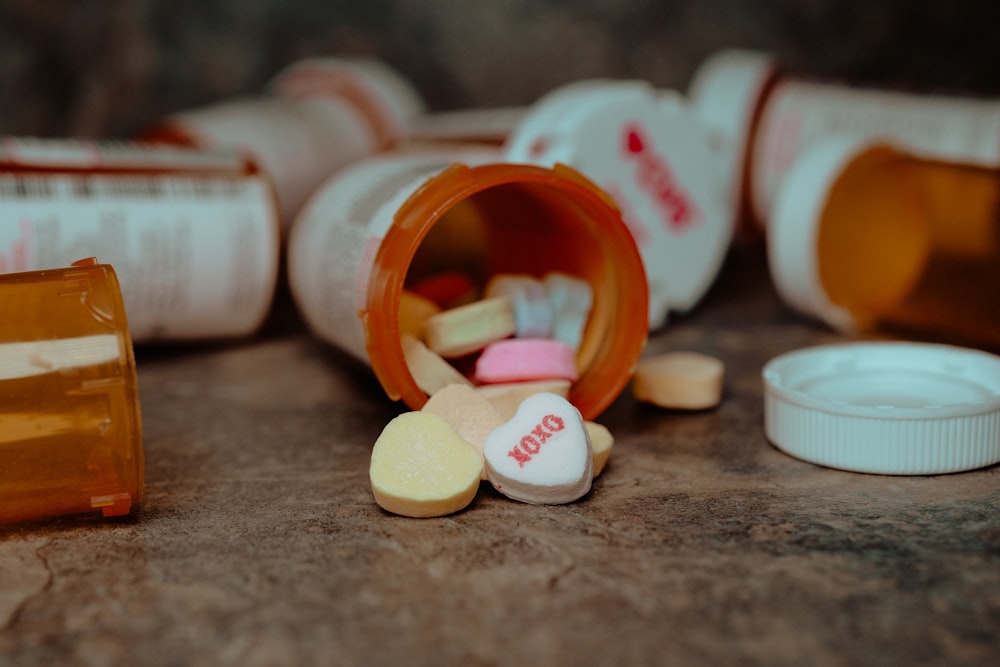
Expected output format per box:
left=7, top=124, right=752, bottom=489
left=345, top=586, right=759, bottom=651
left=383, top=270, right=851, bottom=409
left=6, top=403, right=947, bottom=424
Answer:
left=288, top=152, right=648, bottom=418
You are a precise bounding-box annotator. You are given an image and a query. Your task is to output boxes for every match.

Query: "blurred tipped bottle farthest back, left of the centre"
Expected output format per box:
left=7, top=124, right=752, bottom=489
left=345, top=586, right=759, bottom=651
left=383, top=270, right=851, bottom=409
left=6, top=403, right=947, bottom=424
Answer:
left=143, top=58, right=423, bottom=229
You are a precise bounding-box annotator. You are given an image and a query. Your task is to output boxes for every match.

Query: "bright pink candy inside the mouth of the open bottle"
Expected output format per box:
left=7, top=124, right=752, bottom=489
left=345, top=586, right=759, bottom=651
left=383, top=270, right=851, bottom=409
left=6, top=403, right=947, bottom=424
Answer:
left=475, top=338, right=577, bottom=384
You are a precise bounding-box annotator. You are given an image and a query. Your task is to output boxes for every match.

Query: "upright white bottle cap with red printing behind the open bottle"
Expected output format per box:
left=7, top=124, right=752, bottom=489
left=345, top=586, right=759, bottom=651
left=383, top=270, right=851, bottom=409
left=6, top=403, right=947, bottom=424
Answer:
left=505, top=80, right=732, bottom=328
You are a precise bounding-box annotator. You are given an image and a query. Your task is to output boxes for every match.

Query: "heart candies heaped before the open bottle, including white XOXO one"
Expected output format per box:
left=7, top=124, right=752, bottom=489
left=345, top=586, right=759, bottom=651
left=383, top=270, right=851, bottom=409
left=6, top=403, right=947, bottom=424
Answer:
left=369, top=384, right=614, bottom=517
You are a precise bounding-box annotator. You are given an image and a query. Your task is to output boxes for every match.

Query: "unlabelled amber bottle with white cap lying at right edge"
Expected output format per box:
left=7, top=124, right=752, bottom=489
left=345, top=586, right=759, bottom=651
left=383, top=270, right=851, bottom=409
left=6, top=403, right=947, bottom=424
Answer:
left=767, top=137, right=1000, bottom=350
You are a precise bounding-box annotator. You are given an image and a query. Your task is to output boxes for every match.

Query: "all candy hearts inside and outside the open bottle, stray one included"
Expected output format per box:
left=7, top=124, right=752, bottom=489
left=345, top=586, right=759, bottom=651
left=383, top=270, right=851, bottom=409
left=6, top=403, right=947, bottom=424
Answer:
left=369, top=266, right=723, bottom=517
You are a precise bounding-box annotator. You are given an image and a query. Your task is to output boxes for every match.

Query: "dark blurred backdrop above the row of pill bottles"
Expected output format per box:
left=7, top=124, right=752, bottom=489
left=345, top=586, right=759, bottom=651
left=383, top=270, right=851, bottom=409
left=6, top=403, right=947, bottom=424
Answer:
left=0, top=0, right=1000, bottom=137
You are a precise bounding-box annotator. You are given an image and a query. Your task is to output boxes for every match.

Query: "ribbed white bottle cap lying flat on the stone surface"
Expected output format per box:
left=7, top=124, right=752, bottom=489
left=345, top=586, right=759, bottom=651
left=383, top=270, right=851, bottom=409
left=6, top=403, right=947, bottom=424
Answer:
left=763, top=342, right=1000, bottom=475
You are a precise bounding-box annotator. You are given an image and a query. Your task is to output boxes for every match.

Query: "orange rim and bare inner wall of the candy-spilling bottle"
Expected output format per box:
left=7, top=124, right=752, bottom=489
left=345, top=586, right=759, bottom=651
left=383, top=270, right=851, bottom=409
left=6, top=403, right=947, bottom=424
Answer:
left=362, top=164, right=648, bottom=418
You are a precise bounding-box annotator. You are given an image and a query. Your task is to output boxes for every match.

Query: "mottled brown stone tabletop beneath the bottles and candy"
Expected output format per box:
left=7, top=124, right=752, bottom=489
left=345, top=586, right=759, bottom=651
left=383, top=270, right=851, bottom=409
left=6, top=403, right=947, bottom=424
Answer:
left=0, top=249, right=1000, bottom=666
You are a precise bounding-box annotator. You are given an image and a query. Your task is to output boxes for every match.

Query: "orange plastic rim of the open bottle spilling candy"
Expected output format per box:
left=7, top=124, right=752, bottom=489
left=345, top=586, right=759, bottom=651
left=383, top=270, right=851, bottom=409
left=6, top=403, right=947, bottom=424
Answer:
left=359, top=163, right=648, bottom=419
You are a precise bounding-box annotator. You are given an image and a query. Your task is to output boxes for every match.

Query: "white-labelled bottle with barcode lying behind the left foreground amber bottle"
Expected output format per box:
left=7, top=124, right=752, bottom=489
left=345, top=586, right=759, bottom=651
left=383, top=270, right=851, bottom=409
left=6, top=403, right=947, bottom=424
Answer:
left=0, top=138, right=280, bottom=342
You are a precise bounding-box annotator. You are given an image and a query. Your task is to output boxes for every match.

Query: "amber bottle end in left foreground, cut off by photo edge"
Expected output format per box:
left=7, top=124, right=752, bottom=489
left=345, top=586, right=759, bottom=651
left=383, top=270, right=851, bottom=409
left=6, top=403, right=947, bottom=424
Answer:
left=0, top=259, right=143, bottom=522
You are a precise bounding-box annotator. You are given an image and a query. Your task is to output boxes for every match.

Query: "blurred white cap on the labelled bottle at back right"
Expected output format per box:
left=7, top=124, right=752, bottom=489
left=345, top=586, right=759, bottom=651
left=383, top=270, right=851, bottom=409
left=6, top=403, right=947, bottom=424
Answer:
left=688, top=49, right=778, bottom=230
